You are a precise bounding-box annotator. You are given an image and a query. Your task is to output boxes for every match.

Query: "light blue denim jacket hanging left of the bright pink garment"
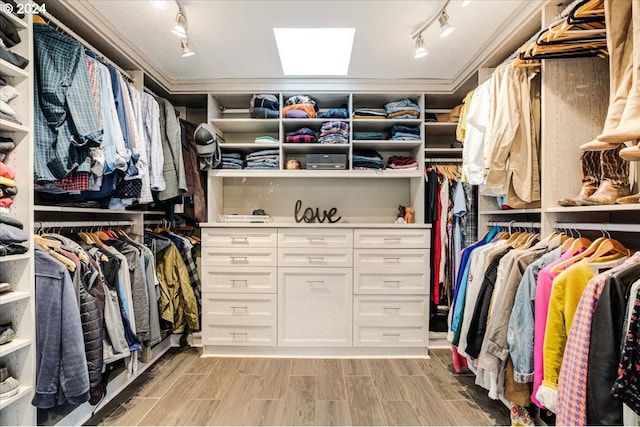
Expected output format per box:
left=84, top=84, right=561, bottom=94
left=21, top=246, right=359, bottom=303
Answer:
left=507, top=248, right=562, bottom=383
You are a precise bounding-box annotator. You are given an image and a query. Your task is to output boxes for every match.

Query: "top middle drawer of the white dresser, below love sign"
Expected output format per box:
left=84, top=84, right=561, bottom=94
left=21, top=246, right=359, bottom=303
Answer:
left=278, top=229, right=353, bottom=248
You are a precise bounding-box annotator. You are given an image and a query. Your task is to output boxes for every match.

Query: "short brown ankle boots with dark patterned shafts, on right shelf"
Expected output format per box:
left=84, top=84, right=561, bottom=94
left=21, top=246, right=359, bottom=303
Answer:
left=558, top=144, right=638, bottom=206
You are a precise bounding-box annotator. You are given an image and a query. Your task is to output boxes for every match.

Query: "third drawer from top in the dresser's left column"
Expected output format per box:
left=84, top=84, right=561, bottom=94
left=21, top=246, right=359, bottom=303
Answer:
left=202, top=265, right=278, bottom=293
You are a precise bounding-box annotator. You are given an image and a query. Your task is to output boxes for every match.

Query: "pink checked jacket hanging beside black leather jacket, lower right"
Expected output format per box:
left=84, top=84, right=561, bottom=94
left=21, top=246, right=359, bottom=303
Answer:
left=556, top=252, right=640, bottom=426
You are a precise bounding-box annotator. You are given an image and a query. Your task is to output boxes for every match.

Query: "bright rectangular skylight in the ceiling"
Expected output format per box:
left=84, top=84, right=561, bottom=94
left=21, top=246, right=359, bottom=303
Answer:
left=273, top=28, right=356, bottom=76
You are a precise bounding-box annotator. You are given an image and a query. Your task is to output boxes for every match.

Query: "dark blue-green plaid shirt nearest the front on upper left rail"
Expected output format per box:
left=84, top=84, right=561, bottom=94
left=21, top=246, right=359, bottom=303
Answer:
left=33, top=24, right=102, bottom=181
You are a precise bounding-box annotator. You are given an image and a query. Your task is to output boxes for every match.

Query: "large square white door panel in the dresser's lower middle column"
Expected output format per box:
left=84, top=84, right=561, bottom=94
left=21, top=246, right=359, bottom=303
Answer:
left=278, top=268, right=353, bottom=347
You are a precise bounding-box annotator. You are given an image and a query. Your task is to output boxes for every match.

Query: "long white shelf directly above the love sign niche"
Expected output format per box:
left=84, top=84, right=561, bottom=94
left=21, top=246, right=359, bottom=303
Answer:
left=210, top=169, right=422, bottom=179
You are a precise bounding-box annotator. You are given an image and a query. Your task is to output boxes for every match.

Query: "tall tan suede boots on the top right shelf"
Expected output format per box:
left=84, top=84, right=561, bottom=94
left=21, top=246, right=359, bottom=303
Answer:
left=580, top=0, right=640, bottom=161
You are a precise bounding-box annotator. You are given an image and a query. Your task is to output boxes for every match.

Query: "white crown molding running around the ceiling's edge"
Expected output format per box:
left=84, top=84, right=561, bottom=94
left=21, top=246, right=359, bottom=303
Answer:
left=47, top=0, right=548, bottom=95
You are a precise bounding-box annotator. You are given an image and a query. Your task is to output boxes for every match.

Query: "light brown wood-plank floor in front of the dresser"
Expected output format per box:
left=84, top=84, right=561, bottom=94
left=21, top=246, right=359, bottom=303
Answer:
left=87, top=348, right=510, bottom=426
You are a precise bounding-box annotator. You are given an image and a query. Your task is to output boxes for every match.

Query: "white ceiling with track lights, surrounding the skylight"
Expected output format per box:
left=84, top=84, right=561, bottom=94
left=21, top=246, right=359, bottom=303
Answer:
left=82, top=0, right=531, bottom=87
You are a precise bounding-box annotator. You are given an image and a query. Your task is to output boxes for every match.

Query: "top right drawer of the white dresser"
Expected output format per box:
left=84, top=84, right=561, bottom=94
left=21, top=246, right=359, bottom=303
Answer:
left=353, top=228, right=431, bottom=248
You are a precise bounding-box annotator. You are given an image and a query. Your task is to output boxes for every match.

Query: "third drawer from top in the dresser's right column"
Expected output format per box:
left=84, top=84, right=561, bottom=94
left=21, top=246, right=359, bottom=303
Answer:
left=353, top=266, right=429, bottom=294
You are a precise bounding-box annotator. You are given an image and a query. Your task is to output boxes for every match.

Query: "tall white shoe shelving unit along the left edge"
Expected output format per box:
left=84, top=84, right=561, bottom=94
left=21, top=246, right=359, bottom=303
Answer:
left=0, top=12, right=36, bottom=425
